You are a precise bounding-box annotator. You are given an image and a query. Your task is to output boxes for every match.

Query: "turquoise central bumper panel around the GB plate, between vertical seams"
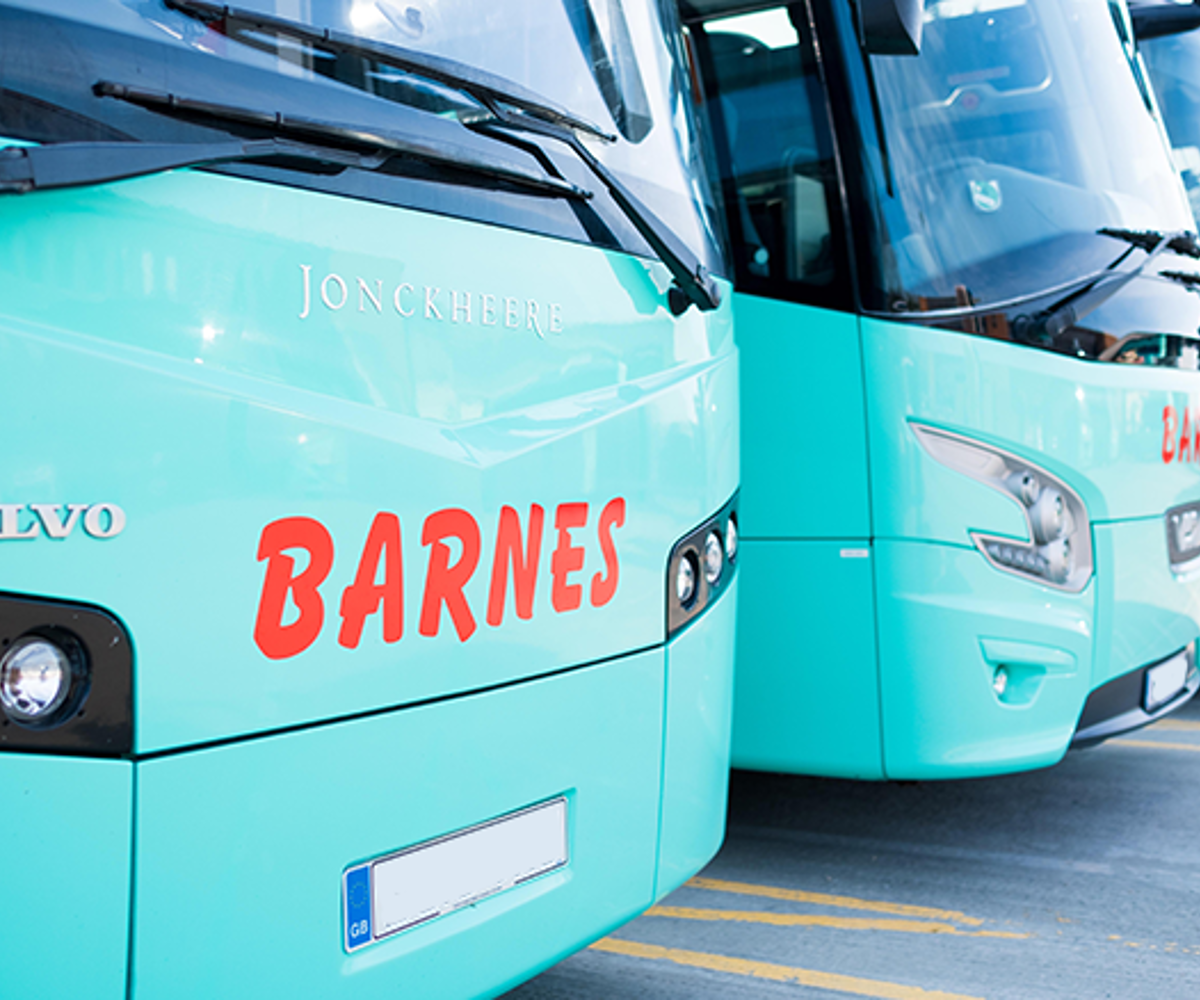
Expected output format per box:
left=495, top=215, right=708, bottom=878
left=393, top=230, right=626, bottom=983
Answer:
left=132, top=649, right=666, bottom=1000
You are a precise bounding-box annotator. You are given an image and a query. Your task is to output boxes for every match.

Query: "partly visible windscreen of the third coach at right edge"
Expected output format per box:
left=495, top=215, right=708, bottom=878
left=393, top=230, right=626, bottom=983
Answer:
left=1140, top=31, right=1200, bottom=218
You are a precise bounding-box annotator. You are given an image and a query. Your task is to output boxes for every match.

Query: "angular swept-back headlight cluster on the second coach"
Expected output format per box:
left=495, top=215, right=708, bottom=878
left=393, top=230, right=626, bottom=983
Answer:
left=910, top=424, right=1092, bottom=593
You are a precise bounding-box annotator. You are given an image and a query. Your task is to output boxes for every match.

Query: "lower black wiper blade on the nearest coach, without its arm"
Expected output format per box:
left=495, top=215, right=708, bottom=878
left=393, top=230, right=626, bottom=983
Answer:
left=87, top=80, right=592, bottom=199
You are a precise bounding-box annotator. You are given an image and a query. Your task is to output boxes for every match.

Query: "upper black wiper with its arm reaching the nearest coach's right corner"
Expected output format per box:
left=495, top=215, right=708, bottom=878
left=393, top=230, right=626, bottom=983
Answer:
left=166, top=0, right=721, bottom=316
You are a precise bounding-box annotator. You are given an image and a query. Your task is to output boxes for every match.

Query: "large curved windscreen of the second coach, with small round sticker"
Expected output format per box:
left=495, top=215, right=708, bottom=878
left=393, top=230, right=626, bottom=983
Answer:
left=862, top=0, right=1195, bottom=311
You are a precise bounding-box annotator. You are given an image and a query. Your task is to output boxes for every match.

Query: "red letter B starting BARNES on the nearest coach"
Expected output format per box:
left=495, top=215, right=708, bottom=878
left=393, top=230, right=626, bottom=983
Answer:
left=254, top=517, right=334, bottom=660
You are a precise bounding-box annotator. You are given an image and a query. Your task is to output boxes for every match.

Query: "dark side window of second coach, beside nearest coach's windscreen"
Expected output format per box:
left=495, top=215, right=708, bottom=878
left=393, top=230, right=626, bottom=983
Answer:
left=697, top=5, right=842, bottom=304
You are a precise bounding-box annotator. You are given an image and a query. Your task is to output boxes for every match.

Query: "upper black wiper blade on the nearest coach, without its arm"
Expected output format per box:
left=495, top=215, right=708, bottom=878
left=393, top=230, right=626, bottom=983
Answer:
left=166, top=0, right=616, bottom=142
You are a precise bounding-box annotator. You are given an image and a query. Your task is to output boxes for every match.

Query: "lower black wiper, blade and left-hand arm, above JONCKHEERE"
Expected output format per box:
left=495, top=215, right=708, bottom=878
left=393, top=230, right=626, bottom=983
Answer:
left=82, top=80, right=592, bottom=199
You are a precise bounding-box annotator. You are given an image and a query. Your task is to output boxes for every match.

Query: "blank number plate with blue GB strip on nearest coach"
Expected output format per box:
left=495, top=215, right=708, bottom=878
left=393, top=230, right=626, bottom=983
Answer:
left=342, top=798, right=568, bottom=951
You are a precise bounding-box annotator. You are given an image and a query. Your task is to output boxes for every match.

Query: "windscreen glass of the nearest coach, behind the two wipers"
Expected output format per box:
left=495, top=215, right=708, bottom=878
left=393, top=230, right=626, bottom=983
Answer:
left=0, top=0, right=722, bottom=271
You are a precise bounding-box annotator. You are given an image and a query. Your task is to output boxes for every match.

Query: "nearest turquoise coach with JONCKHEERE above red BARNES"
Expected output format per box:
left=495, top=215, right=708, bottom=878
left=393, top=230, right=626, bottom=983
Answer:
left=0, top=0, right=739, bottom=1000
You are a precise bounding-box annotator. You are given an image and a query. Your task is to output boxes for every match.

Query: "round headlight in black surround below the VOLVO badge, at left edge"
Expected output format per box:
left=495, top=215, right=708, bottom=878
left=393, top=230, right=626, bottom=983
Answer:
left=0, top=634, right=86, bottom=729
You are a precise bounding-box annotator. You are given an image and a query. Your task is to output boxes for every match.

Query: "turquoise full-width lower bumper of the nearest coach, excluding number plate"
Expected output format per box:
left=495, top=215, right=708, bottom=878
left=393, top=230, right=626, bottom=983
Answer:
left=0, top=582, right=736, bottom=1000
